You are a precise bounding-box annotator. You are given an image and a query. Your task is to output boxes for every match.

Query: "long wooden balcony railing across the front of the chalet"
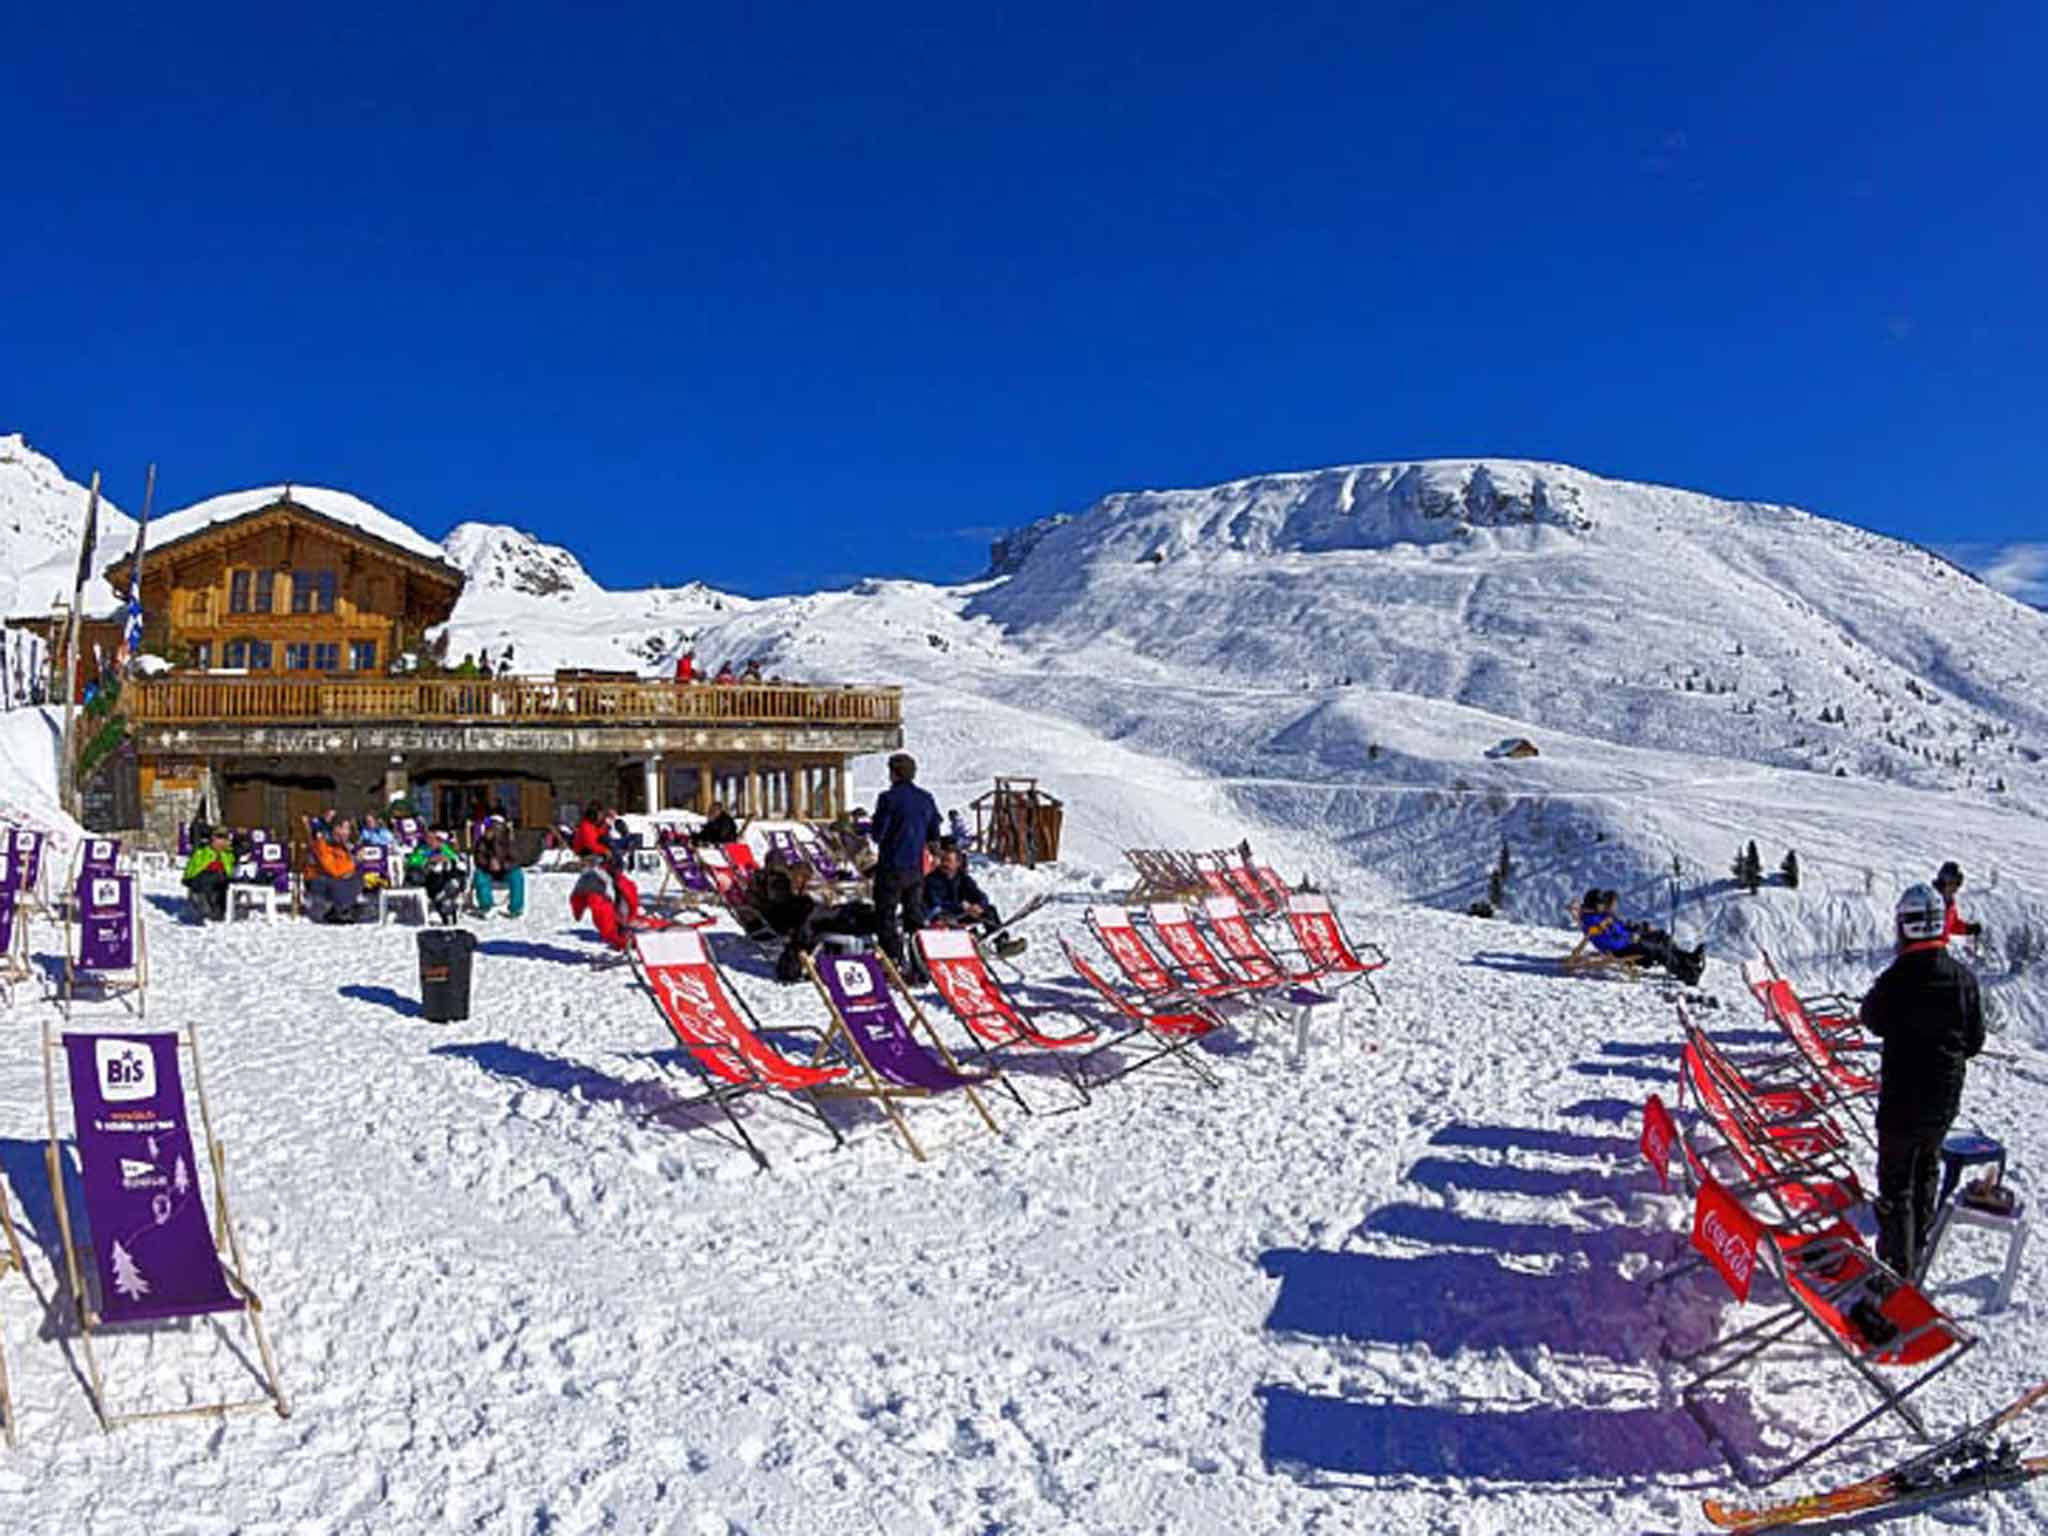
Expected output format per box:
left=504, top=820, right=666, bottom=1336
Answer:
left=121, top=678, right=903, bottom=725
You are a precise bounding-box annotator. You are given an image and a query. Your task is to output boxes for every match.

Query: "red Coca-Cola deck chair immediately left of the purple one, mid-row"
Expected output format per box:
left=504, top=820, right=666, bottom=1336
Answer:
left=631, top=928, right=848, bottom=1169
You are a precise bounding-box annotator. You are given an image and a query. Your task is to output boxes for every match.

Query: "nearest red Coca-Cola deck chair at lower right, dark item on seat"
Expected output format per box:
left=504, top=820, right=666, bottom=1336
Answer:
left=1679, top=1178, right=1976, bottom=1485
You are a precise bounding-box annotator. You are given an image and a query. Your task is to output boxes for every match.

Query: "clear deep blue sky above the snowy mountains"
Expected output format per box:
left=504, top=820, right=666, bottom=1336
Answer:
left=0, top=0, right=2048, bottom=592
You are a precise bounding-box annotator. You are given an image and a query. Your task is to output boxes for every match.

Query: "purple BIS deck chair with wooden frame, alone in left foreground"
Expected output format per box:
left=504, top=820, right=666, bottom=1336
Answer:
left=43, top=1024, right=291, bottom=1430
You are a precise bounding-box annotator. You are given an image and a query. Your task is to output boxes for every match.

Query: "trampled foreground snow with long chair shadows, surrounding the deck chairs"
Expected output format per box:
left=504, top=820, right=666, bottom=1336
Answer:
left=0, top=874, right=2048, bottom=1536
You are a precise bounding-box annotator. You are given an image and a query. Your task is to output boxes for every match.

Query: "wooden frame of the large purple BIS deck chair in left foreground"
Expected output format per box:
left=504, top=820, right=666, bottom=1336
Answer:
left=43, top=1018, right=291, bottom=1432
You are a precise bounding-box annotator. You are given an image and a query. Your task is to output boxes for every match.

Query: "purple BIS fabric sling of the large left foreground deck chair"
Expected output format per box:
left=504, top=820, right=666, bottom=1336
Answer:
left=63, top=1034, right=242, bottom=1323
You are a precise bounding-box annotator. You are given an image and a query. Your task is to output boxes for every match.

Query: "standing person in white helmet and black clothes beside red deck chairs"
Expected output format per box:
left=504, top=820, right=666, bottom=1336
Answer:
left=1862, top=885, right=1985, bottom=1278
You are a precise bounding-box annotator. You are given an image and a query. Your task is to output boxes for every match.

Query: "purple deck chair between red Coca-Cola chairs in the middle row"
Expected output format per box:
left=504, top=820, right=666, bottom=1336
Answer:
left=803, top=952, right=1007, bottom=1163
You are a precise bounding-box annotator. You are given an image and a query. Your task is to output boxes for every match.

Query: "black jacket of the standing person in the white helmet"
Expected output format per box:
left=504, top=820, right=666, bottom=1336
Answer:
left=1862, top=944, right=1985, bottom=1130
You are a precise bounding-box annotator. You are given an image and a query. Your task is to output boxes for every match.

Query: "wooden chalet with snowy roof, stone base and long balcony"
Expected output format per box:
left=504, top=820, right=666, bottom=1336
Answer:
left=16, top=485, right=903, bottom=844
